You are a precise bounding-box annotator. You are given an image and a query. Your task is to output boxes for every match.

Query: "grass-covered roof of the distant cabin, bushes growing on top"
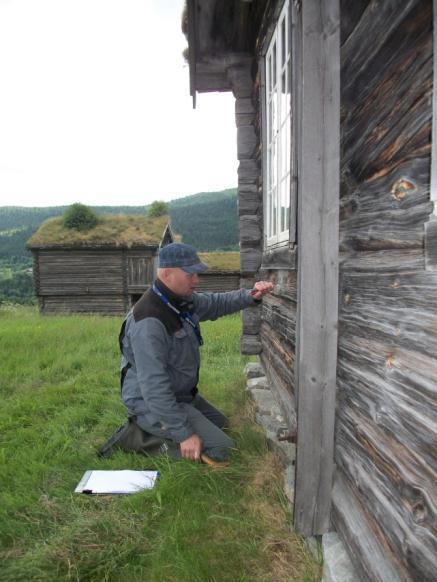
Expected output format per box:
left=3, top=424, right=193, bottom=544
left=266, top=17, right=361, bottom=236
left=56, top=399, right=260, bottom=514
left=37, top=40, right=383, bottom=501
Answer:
left=27, top=214, right=169, bottom=247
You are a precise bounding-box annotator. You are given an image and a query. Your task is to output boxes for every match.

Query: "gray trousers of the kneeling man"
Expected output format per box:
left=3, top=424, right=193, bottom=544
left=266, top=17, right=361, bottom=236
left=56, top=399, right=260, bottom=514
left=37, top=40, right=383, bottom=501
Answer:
left=136, top=394, right=234, bottom=460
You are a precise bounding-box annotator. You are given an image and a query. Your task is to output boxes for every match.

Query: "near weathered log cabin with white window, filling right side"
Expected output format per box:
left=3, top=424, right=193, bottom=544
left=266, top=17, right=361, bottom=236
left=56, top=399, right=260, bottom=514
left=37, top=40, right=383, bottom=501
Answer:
left=183, top=0, right=437, bottom=582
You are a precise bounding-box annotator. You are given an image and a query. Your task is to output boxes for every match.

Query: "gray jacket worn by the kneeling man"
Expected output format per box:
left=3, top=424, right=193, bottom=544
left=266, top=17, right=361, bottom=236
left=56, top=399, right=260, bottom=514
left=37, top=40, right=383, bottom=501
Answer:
left=120, top=289, right=259, bottom=442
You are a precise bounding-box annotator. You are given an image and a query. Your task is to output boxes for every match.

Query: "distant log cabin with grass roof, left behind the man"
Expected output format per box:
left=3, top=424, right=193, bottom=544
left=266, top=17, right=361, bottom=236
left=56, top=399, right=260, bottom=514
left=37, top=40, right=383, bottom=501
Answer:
left=27, top=215, right=174, bottom=315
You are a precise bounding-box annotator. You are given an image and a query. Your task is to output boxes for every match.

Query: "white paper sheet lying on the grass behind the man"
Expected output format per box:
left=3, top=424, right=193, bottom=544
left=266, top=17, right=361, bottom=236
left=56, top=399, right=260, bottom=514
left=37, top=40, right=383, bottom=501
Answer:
left=74, top=469, right=159, bottom=495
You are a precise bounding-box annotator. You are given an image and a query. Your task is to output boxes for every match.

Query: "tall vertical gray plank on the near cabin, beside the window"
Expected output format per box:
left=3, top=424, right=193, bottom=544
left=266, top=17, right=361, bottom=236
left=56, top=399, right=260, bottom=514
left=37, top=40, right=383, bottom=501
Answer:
left=294, top=0, right=340, bottom=536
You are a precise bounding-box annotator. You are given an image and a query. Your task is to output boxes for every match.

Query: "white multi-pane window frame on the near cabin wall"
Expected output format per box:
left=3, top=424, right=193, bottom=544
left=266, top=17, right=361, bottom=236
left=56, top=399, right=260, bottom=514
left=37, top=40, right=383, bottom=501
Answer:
left=263, top=0, right=294, bottom=248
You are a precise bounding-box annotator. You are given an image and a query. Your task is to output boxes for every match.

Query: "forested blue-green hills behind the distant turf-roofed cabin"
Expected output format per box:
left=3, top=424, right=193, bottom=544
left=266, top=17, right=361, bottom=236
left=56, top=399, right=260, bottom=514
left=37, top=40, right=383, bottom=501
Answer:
left=0, top=188, right=238, bottom=264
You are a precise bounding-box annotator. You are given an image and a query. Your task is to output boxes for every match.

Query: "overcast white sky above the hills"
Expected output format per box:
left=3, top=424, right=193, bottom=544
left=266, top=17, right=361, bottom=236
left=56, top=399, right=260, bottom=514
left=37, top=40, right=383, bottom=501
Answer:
left=0, top=0, right=237, bottom=206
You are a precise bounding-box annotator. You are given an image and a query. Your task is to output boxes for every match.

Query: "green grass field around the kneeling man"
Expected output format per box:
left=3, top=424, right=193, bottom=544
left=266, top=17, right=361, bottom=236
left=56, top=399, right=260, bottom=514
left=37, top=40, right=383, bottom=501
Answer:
left=0, top=307, right=320, bottom=582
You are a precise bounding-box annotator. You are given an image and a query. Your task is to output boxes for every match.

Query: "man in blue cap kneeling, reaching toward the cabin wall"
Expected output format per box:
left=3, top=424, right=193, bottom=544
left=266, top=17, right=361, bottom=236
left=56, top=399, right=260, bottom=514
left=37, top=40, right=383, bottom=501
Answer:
left=104, top=243, right=273, bottom=461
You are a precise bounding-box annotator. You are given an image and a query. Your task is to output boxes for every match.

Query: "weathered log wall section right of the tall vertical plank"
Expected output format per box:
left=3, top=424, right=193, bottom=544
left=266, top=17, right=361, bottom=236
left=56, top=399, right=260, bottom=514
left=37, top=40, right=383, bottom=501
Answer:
left=332, top=0, right=437, bottom=582
